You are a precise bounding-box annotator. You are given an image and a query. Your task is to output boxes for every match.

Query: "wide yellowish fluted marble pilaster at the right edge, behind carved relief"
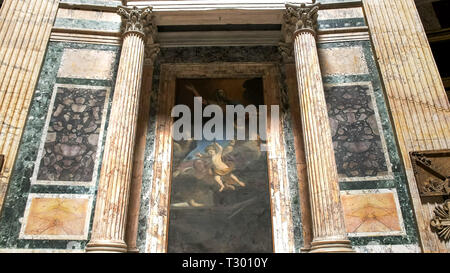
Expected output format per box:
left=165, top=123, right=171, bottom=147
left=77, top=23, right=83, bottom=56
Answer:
left=362, top=0, right=450, bottom=252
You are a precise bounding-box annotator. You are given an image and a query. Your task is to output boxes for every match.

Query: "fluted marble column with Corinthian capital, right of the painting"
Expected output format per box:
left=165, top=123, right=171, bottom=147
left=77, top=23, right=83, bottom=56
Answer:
left=285, top=4, right=353, bottom=252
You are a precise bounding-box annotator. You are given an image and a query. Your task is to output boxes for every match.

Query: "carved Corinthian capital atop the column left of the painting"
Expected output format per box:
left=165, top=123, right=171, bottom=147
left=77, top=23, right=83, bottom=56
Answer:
left=117, top=6, right=155, bottom=36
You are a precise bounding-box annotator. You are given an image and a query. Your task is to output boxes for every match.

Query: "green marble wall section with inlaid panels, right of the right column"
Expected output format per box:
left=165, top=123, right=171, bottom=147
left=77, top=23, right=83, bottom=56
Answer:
left=319, top=41, right=420, bottom=252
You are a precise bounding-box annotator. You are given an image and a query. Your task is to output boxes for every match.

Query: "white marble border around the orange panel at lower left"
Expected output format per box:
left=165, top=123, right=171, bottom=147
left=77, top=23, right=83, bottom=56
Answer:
left=19, top=193, right=94, bottom=240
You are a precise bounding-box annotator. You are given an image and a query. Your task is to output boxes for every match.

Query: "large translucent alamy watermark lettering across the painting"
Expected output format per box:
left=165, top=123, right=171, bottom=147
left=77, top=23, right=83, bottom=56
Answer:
left=171, top=97, right=279, bottom=151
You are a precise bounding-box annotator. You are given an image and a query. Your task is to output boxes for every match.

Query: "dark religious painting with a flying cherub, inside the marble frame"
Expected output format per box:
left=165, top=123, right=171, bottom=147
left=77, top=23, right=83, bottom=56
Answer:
left=167, top=78, right=273, bottom=253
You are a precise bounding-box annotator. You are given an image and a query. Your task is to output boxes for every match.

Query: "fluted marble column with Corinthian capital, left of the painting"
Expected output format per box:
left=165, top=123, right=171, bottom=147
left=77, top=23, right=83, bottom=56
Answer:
left=86, top=7, right=156, bottom=252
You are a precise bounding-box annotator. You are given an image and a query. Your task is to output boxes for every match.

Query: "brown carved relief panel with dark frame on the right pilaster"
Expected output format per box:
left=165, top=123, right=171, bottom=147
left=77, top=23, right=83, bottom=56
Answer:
left=411, top=150, right=450, bottom=197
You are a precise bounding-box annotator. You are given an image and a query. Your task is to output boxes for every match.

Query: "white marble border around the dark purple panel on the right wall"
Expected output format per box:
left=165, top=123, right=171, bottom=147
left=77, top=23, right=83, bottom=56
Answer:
left=324, top=82, right=394, bottom=182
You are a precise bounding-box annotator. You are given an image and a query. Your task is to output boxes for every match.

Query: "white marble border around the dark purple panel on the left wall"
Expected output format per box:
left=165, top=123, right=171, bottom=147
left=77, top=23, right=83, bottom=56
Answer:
left=31, top=84, right=111, bottom=187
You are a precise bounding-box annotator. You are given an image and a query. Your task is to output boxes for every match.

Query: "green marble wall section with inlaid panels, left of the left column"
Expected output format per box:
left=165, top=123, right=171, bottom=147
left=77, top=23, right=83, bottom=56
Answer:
left=0, top=42, right=119, bottom=252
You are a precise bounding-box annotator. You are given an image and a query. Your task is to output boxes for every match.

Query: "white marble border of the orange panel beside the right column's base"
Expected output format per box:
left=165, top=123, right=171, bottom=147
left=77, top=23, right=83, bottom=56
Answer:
left=340, top=188, right=406, bottom=237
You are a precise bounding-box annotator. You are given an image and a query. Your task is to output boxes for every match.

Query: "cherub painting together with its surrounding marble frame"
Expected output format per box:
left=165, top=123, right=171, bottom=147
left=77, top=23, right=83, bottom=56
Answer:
left=145, top=63, right=295, bottom=253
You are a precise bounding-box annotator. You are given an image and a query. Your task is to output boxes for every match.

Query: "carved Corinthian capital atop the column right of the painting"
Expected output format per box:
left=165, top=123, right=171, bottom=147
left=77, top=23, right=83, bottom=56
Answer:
left=283, top=0, right=320, bottom=43
